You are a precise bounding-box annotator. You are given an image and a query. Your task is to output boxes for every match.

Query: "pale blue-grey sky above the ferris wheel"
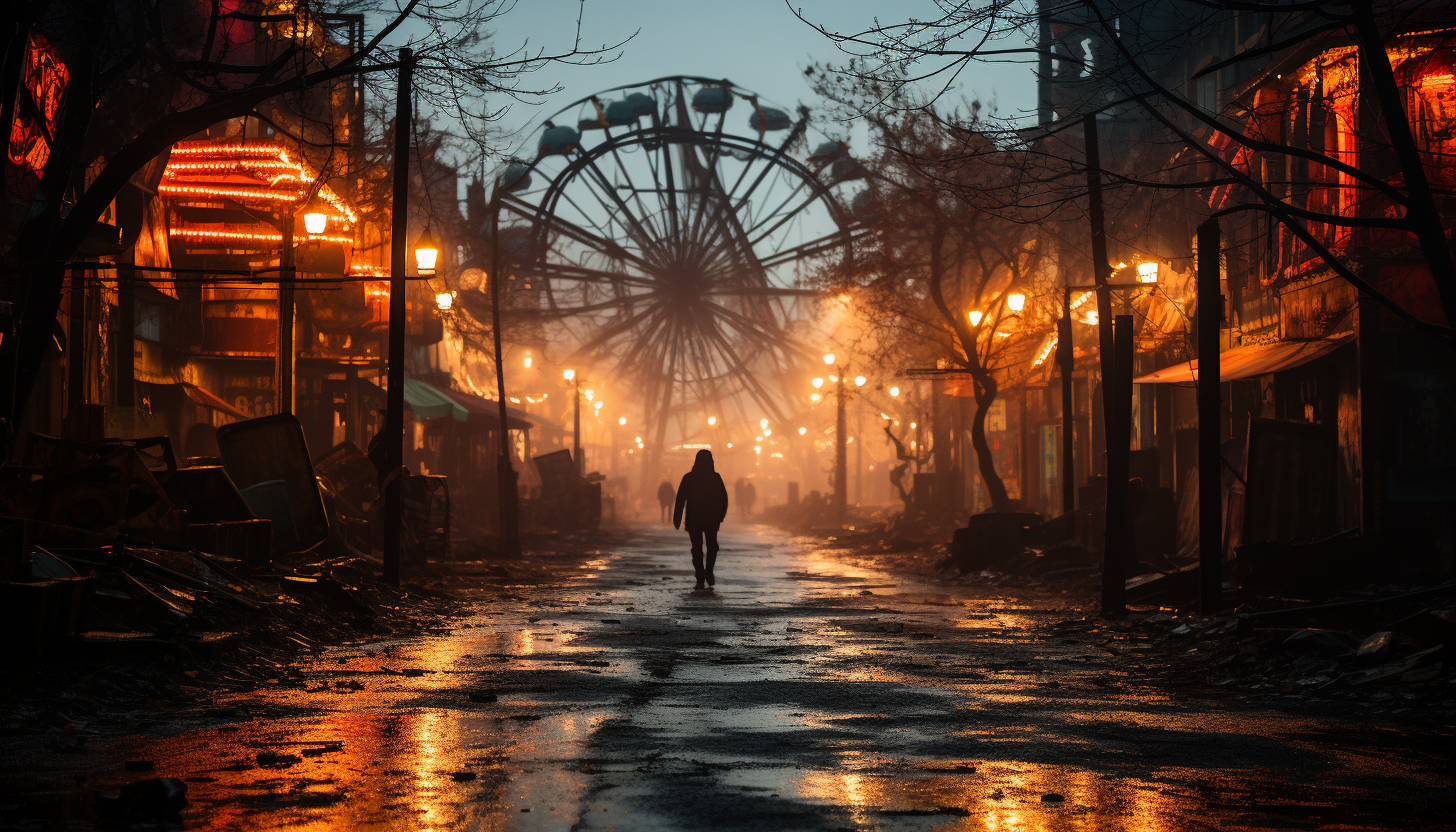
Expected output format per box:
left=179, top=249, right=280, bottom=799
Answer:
left=477, top=0, right=1035, bottom=154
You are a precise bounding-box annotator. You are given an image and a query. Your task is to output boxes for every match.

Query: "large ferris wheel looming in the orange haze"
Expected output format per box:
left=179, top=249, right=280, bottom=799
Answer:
left=498, top=76, right=863, bottom=449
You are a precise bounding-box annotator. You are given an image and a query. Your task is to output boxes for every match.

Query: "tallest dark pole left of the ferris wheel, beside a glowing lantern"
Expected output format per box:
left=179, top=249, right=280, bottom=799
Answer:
left=380, top=48, right=415, bottom=586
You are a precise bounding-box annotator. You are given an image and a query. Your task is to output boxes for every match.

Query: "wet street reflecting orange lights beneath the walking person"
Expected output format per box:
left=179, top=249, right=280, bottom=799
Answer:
left=0, top=527, right=1456, bottom=832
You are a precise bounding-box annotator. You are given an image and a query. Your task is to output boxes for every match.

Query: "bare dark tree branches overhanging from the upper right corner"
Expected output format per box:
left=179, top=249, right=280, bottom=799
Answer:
left=811, top=0, right=1456, bottom=344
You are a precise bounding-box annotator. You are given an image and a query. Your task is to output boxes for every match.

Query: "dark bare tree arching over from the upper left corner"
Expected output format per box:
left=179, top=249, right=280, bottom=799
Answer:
left=0, top=0, right=614, bottom=444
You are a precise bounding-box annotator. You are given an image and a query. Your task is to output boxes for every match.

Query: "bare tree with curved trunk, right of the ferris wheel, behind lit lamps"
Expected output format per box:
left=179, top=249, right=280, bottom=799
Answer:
left=824, top=112, right=1051, bottom=509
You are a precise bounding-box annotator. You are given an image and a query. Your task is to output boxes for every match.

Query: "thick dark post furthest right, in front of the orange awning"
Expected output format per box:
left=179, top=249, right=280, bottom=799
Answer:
left=1197, top=220, right=1223, bottom=615
